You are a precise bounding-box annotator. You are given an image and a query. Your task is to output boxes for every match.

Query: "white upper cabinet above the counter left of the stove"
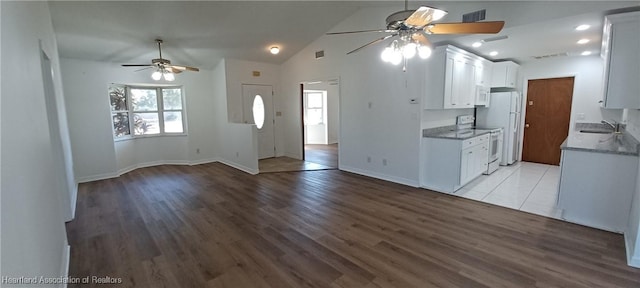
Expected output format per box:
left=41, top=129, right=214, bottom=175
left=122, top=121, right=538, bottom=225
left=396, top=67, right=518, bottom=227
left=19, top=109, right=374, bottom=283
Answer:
left=424, top=45, right=477, bottom=109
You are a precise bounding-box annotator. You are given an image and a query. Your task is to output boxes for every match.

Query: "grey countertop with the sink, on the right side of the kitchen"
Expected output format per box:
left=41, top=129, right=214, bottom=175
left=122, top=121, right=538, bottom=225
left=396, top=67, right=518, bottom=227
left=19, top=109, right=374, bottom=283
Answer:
left=560, top=123, right=640, bottom=156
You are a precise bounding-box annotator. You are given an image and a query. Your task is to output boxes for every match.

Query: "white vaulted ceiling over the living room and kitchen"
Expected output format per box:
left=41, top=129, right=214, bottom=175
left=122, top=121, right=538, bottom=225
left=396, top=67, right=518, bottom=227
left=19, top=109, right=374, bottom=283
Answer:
left=49, top=1, right=640, bottom=68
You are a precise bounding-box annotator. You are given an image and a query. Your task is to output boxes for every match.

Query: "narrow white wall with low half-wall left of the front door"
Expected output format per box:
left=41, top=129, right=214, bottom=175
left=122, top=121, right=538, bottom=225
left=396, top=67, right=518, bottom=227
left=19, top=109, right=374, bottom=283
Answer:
left=212, top=60, right=258, bottom=174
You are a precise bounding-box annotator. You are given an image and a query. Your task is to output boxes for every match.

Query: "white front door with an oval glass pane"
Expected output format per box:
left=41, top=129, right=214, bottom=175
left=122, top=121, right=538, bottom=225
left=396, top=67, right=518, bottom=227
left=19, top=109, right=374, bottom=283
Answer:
left=242, top=84, right=276, bottom=159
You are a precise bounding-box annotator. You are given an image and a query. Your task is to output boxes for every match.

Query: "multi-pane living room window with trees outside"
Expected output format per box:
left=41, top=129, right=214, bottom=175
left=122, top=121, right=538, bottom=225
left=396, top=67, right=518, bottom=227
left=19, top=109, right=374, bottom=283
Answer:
left=109, top=84, right=185, bottom=139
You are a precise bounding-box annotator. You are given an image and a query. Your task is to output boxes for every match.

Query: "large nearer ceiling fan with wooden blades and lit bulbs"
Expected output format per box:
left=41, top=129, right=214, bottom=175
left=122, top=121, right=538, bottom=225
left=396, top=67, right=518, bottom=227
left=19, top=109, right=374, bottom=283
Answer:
left=327, top=0, right=504, bottom=65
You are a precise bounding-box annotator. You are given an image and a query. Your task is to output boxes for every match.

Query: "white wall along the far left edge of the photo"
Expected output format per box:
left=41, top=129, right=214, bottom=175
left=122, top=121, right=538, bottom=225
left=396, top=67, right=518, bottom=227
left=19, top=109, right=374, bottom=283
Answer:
left=0, top=1, right=73, bottom=277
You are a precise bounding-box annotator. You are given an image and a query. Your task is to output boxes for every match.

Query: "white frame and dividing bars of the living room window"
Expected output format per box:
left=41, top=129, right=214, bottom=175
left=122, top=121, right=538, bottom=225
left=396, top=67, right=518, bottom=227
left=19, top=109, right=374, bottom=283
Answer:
left=109, top=83, right=188, bottom=142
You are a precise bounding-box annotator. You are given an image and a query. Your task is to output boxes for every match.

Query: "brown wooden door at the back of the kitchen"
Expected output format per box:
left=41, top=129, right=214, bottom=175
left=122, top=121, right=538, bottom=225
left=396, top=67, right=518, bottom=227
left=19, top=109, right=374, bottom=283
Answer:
left=522, top=77, right=574, bottom=165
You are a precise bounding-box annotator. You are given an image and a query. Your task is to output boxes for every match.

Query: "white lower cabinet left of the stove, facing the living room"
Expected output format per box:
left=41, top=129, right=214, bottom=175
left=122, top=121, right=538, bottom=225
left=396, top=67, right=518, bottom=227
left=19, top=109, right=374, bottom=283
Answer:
left=421, top=134, right=489, bottom=193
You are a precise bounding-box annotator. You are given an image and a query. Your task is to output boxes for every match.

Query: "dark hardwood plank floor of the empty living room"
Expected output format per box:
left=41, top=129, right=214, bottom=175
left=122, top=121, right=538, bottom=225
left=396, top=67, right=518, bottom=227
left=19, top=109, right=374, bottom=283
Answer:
left=67, top=163, right=640, bottom=288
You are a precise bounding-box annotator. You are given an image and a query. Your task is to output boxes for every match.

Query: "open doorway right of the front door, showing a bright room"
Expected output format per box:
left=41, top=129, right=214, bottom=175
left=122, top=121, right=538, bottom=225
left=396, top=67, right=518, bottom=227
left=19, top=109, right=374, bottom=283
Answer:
left=300, top=79, right=340, bottom=168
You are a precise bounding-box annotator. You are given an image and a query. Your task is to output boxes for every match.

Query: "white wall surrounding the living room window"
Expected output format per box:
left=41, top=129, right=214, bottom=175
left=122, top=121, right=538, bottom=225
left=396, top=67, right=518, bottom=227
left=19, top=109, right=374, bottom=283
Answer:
left=62, top=58, right=217, bottom=182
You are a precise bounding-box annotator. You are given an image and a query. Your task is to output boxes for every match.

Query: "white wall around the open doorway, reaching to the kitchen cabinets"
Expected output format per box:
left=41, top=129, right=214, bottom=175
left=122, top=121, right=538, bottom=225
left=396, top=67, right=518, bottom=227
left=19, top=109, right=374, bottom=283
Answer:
left=280, top=7, right=432, bottom=186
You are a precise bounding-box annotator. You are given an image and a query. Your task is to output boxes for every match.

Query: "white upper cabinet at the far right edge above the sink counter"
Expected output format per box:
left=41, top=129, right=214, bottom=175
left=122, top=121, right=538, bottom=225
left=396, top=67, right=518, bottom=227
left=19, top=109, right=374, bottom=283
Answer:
left=601, top=11, right=640, bottom=109
